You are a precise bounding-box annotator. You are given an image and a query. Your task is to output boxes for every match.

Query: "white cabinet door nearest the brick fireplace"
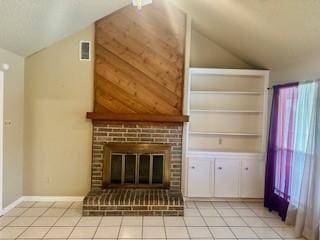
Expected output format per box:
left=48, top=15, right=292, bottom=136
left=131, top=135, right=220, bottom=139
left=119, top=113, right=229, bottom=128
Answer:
left=188, top=159, right=213, bottom=197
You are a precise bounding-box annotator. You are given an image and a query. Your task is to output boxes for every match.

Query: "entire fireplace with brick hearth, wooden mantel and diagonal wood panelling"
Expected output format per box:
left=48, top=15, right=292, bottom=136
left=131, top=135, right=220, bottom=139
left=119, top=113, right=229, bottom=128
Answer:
left=83, top=0, right=188, bottom=216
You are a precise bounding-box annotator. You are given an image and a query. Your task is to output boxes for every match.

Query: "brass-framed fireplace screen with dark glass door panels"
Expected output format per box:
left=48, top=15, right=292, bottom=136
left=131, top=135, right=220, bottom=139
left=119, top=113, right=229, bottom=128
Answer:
left=103, top=144, right=170, bottom=187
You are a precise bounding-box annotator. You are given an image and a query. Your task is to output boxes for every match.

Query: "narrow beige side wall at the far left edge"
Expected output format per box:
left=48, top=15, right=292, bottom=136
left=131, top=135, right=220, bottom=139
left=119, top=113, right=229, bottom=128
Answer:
left=0, top=48, right=24, bottom=207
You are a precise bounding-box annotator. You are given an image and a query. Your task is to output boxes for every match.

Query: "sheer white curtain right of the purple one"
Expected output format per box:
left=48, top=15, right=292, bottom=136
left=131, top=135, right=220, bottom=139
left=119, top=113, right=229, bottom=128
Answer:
left=286, top=81, right=320, bottom=240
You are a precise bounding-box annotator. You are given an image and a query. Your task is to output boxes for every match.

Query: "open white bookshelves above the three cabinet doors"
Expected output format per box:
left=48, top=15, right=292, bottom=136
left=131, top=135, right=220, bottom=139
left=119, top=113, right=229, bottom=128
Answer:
left=187, top=68, right=268, bottom=153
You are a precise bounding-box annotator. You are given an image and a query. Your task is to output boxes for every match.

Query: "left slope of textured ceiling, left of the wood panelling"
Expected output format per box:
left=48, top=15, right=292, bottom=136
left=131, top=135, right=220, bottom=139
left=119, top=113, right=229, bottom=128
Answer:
left=0, top=0, right=131, bottom=56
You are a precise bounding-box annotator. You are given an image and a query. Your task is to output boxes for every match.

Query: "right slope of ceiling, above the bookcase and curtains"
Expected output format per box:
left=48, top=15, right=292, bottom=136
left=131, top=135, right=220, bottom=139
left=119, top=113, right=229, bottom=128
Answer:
left=172, top=0, right=320, bottom=69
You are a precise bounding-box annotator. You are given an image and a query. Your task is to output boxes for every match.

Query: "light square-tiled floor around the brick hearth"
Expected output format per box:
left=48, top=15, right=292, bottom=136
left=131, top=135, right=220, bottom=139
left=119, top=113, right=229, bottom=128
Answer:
left=0, top=202, right=302, bottom=240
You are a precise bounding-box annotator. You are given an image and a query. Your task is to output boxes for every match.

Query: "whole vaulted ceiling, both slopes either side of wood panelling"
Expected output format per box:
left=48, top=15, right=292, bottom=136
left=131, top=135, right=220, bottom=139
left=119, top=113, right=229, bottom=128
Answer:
left=0, top=0, right=320, bottom=69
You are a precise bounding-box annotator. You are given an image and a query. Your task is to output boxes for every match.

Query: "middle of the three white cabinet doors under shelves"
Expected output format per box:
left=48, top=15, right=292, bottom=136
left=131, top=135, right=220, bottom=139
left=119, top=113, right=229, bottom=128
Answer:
left=214, top=158, right=240, bottom=197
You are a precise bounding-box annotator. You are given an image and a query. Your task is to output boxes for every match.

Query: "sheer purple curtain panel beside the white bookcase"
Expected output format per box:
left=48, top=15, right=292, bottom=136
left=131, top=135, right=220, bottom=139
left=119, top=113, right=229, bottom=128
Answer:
left=264, top=83, right=298, bottom=220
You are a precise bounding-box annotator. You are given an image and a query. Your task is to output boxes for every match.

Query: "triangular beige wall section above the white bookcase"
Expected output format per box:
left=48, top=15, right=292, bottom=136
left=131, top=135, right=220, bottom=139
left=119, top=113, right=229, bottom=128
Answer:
left=191, top=30, right=252, bottom=68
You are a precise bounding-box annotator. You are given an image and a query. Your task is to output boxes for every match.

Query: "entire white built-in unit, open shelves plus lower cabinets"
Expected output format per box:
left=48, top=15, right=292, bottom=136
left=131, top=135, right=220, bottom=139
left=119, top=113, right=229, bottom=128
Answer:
left=184, top=68, right=269, bottom=200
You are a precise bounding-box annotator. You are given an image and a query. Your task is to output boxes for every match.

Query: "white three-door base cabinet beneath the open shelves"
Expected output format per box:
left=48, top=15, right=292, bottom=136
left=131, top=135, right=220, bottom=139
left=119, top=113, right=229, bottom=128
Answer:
left=187, top=152, right=265, bottom=198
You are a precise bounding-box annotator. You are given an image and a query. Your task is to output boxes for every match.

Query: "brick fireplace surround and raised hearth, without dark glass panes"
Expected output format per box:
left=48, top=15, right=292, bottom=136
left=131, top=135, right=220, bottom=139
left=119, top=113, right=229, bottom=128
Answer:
left=83, top=121, right=183, bottom=216
